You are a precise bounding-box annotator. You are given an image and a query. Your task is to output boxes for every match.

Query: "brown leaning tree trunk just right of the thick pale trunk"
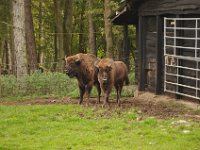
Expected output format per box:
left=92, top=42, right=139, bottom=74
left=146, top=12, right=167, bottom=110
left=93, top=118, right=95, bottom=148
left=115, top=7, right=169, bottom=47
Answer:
left=24, top=0, right=38, bottom=71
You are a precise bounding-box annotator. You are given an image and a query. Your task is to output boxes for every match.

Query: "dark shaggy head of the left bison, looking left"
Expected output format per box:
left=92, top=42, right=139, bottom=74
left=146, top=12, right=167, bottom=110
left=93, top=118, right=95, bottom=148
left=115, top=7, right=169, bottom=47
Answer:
left=65, top=55, right=81, bottom=78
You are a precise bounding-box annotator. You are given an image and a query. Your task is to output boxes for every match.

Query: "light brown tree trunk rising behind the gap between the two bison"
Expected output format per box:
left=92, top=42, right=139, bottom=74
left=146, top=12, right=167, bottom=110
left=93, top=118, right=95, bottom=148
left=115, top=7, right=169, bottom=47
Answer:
left=88, top=0, right=97, bottom=56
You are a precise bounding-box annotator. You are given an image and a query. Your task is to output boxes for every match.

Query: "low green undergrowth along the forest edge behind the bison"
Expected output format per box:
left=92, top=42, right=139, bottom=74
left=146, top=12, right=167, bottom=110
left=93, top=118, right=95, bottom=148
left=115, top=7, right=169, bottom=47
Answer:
left=0, top=71, right=134, bottom=100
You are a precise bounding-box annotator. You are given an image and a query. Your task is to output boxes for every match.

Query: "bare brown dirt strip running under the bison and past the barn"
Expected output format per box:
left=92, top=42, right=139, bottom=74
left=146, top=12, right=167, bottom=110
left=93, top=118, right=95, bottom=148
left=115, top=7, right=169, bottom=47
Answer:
left=0, top=93, right=200, bottom=122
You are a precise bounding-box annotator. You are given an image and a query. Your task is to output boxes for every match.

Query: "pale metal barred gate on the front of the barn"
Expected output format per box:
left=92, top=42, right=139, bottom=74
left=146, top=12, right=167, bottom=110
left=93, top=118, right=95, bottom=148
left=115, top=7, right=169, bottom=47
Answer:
left=164, top=18, right=200, bottom=100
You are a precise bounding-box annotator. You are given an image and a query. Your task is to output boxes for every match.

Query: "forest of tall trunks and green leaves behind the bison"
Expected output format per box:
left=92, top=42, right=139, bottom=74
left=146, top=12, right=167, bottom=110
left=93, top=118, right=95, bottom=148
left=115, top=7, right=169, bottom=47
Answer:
left=0, top=0, right=136, bottom=77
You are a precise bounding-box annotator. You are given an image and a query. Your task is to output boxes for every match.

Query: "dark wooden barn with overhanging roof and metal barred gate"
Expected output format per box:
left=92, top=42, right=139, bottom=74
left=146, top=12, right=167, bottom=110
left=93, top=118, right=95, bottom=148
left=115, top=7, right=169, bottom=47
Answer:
left=110, top=0, right=200, bottom=100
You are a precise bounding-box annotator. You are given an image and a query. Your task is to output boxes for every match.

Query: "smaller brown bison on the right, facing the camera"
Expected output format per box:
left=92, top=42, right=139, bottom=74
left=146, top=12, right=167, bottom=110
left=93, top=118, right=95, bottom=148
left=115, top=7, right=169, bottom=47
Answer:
left=96, top=58, right=129, bottom=106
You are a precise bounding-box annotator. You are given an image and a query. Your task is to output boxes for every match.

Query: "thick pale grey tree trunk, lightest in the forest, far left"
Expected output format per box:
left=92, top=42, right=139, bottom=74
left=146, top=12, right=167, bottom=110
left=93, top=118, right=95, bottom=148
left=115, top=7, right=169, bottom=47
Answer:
left=12, top=0, right=27, bottom=79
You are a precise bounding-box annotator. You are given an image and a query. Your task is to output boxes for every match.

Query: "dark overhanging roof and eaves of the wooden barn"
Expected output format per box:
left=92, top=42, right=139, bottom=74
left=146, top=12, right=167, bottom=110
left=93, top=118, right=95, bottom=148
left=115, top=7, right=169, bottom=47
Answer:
left=110, top=0, right=200, bottom=25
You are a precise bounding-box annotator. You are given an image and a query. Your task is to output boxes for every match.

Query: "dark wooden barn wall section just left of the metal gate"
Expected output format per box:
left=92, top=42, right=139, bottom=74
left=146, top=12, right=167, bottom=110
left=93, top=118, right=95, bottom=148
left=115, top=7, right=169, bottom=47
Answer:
left=137, top=16, right=164, bottom=94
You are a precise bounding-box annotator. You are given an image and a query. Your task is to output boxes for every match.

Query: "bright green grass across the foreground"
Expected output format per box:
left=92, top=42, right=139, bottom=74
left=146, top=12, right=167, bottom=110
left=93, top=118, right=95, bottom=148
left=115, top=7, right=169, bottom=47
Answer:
left=0, top=105, right=200, bottom=150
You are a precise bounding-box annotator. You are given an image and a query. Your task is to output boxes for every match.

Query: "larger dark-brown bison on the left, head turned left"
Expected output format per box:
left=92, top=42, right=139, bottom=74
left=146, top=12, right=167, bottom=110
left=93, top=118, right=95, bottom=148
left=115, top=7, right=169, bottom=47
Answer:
left=65, top=53, right=101, bottom=104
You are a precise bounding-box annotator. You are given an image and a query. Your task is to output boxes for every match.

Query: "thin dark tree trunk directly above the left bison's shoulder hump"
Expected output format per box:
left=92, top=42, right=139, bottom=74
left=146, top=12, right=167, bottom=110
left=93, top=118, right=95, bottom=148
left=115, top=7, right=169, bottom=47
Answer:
left=79, top=0, right=86, bottom=53
